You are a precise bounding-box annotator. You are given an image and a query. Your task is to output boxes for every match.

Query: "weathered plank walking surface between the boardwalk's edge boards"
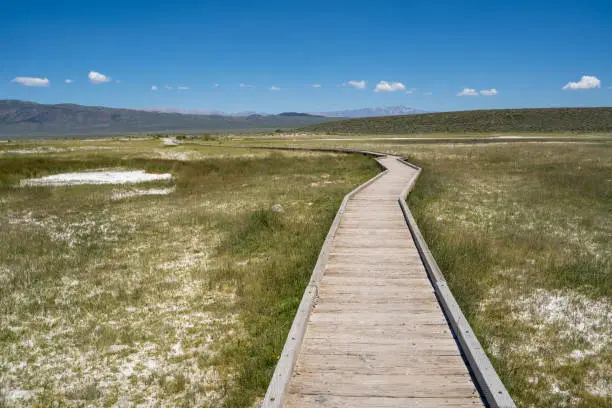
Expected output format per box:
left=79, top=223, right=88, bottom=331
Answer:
left=285, top=157, right=483, bottom=408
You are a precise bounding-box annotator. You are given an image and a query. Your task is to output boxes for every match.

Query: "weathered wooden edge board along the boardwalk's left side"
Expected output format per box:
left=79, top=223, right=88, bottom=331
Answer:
left=261, top=152, right=388, bottom=408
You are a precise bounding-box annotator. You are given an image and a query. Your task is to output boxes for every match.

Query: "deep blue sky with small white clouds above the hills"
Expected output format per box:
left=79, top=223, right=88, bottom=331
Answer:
left=0, top=0, right=612, bottom=112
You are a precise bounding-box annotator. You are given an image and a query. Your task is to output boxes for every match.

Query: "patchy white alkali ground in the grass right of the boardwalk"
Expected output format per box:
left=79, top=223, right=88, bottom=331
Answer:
left=480, top=286, right=612, bottom=400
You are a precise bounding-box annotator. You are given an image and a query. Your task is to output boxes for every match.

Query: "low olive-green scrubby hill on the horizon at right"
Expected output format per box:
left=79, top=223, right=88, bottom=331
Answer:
left=301, top=107, right=612, bottom=134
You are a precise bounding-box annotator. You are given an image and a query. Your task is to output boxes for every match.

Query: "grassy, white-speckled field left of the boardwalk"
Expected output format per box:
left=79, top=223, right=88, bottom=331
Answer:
left=0, top=140, right=378, bottom=408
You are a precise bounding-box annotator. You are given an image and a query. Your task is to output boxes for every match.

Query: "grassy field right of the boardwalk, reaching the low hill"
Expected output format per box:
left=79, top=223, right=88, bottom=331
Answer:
left=253, top=141, right=612, bottom=407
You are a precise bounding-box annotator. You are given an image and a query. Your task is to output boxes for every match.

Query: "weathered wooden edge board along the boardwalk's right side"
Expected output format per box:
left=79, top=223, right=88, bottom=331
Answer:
left=398, top=159, right=516, bottom=408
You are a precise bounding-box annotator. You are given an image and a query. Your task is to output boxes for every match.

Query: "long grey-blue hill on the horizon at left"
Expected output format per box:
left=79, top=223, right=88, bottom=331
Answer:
left=0, top=100, right=332, bottom=138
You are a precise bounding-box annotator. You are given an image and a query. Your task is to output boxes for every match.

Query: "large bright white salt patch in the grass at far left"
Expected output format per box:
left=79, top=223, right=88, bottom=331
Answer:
left=20, top=170, right=172, bottom=186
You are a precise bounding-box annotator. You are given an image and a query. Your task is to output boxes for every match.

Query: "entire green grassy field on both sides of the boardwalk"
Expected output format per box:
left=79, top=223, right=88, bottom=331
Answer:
left=0, top=138, right=612, bottom=407
